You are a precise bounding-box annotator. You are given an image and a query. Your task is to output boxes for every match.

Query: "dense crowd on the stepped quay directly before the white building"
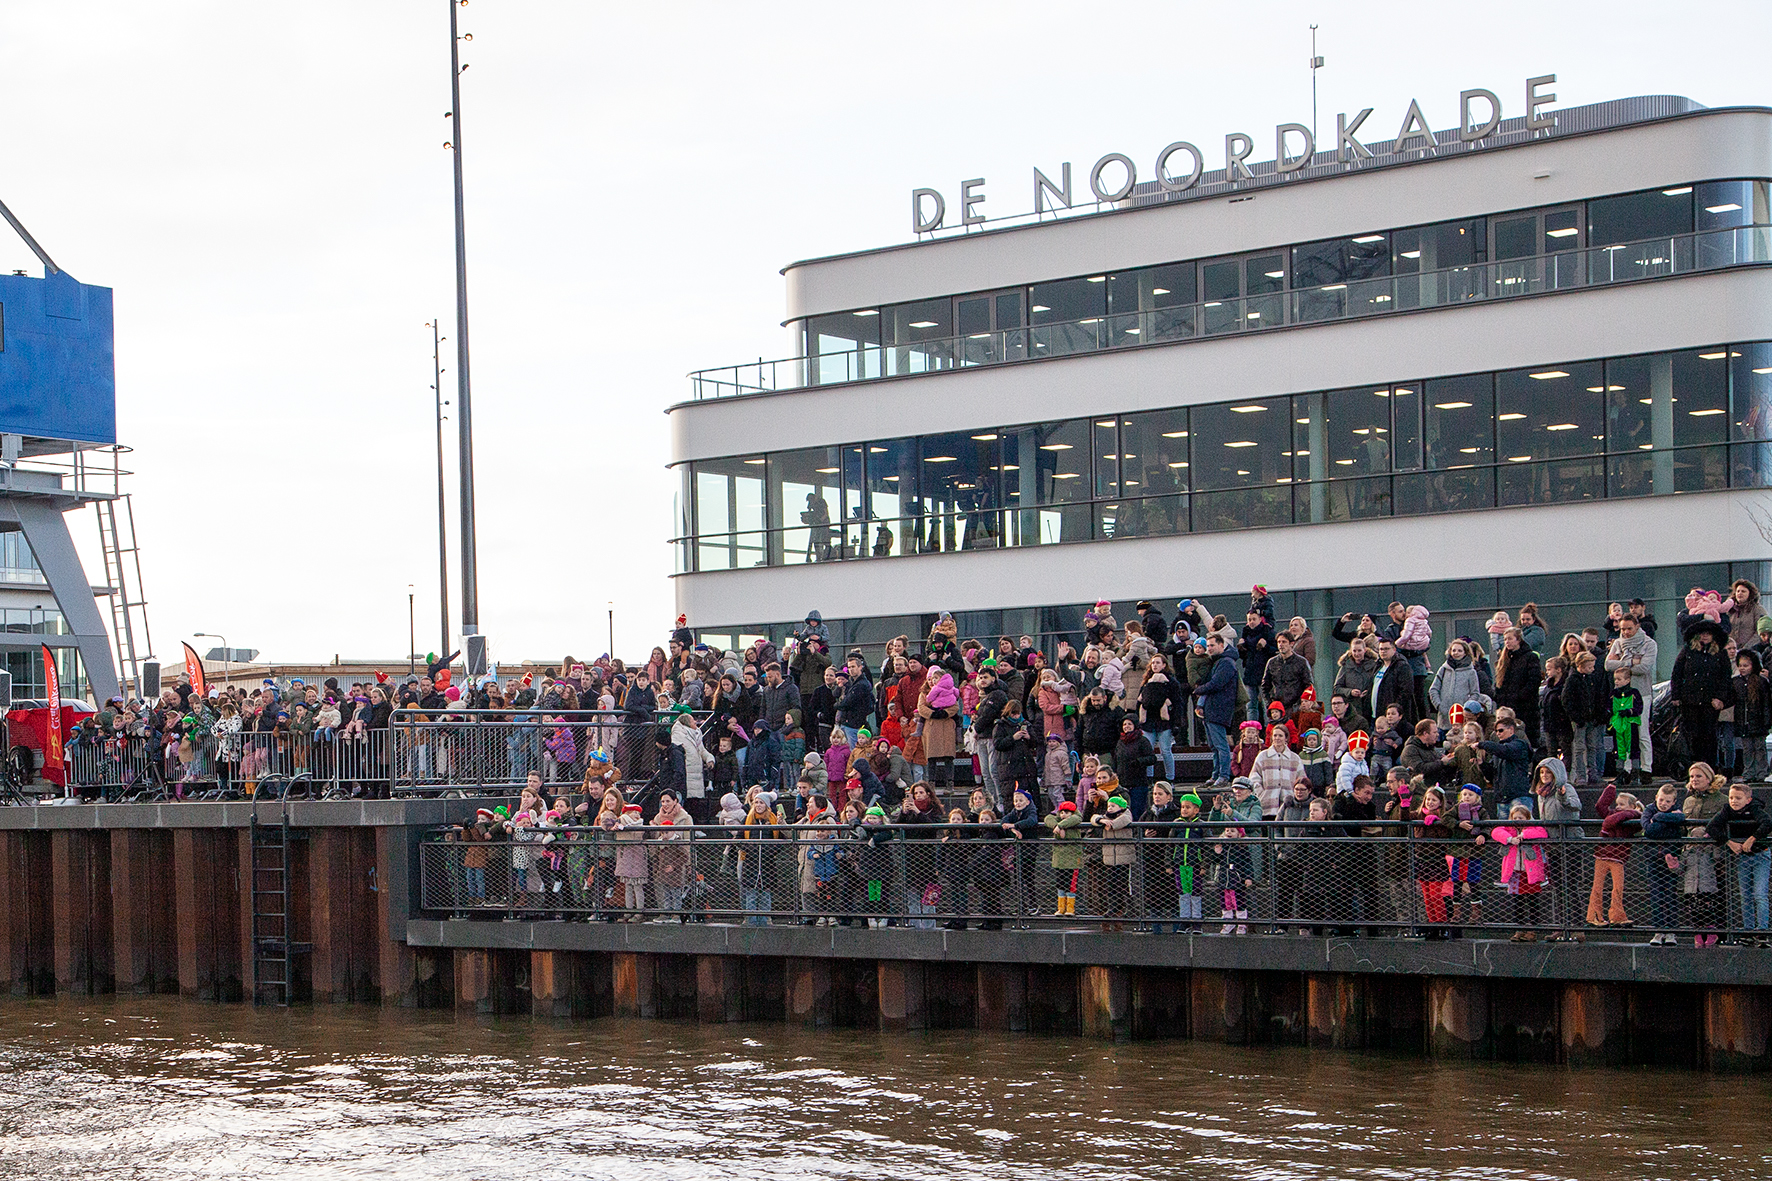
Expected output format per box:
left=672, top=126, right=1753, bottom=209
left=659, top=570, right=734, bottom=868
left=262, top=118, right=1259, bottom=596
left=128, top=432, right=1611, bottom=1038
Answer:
left=435, top=580, right=1772, bottom=947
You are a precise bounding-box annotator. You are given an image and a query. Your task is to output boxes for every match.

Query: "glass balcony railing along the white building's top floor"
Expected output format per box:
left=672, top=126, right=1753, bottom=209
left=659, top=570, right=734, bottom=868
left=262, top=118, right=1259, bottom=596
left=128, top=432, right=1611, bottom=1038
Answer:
left=689, top=225, right=1772, bottom=401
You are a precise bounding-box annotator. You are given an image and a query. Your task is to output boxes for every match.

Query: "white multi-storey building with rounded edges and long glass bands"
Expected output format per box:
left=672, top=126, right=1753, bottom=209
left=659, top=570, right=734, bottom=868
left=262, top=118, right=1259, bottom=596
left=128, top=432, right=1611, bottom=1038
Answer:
left=668, top=98, right=1772, bottom=670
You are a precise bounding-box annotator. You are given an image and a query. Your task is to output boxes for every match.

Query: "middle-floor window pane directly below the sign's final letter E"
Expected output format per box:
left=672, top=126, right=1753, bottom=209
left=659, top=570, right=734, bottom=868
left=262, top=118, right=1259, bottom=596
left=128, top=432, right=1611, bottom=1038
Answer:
left=1496, top=362, right=1605, bottom=505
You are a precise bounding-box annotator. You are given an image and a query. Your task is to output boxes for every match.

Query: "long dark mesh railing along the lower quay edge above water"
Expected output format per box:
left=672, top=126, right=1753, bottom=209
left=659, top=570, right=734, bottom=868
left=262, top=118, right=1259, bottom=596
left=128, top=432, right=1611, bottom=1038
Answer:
left=420, top=821, right=1772, bottom=943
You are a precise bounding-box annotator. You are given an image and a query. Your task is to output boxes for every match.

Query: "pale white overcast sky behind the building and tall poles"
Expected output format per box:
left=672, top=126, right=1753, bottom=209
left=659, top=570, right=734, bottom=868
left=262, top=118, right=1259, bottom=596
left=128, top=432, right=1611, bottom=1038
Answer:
left=0, top=0, right=1772, bottom=661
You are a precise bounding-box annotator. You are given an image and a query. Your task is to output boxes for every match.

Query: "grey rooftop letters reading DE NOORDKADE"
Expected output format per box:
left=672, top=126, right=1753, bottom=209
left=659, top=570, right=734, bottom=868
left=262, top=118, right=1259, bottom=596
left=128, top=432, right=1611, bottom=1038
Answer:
left=911, top=74, right=1556, bottom=234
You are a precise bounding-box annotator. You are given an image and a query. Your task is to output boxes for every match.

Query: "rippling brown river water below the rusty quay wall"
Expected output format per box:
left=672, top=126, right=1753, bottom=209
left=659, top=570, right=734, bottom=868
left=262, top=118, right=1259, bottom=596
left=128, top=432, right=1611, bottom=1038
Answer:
left=0, top=997, right=1772, bottom=1181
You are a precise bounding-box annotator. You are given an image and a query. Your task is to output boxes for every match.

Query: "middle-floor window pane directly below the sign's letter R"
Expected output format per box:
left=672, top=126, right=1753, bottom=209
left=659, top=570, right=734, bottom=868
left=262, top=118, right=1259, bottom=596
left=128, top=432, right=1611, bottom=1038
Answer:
left=1189, top=397, right=1292, bottom=528
